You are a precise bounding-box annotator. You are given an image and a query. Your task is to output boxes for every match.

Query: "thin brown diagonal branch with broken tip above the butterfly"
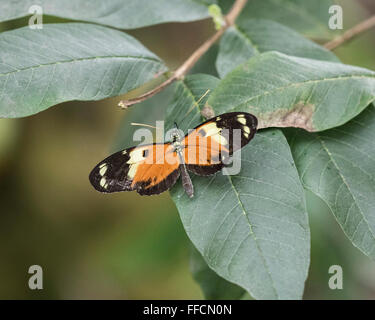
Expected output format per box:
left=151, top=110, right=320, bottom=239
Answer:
left=118, top=0, right=247, bottom=109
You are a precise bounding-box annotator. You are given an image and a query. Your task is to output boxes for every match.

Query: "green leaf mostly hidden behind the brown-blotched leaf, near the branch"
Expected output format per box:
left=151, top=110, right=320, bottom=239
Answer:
left=216, top=19, right=339, bottom=77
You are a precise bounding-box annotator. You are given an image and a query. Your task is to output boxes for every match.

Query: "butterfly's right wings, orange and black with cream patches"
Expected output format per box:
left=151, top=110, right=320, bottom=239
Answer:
left=184, top=112, right=257, bottom=176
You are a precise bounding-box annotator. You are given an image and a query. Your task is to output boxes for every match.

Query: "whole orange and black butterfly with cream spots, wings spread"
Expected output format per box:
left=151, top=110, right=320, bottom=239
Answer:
left=89, top=112, right=258, bottom=198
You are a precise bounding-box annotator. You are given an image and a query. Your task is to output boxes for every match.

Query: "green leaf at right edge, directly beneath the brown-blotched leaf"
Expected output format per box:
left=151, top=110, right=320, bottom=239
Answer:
left=288, top=105, right=375, bottom=259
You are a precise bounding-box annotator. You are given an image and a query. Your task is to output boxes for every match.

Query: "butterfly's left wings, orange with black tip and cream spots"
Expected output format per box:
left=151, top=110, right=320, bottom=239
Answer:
left=89, top=144, right=180, bottom=195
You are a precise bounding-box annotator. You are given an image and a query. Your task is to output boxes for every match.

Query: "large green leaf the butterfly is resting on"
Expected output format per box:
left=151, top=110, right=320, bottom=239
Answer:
left=167, top=75, right=310, bottom=299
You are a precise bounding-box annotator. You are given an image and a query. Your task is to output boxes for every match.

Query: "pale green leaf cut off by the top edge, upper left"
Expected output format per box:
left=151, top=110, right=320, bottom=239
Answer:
left=0, top=0, right=216, bottom=29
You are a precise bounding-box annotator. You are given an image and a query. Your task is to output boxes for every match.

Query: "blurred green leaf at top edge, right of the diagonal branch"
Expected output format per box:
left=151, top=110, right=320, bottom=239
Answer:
left=219, top=0, right=334, bottom=38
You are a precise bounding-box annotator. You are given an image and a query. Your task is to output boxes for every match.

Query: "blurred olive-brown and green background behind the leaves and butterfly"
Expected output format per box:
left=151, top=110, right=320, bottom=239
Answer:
left=0, top=0, right=375, bottom=299
